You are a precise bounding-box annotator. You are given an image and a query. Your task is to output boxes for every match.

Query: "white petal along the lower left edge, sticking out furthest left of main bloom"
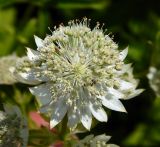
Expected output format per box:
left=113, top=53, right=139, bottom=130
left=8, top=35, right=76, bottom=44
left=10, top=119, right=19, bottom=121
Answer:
left=10, top=68, right=41, bottom=85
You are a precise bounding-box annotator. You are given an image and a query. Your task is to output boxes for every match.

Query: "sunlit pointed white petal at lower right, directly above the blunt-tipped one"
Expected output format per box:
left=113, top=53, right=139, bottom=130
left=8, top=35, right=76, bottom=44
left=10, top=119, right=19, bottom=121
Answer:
left=102, top=95, right=126, bottom=112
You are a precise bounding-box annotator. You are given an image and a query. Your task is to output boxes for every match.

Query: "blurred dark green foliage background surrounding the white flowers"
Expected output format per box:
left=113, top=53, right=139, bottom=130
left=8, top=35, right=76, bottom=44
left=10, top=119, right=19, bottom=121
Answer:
left=0, top=0, right=160, bottom=147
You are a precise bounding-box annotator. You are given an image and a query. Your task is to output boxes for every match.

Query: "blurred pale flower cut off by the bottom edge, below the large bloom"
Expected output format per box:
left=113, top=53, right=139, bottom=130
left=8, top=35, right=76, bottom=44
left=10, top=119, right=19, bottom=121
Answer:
left=73, top=134, right=119, bottom=147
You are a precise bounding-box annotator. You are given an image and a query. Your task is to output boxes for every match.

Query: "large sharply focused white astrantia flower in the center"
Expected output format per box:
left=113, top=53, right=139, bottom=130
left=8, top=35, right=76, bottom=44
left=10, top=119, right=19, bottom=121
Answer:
left=13, top=19, right=142, bottom=130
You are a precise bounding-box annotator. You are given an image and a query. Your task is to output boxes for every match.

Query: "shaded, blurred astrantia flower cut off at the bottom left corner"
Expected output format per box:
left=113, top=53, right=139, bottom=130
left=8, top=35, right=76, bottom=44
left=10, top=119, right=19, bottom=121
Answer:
left=0, top=105, right=28, bottom=147
